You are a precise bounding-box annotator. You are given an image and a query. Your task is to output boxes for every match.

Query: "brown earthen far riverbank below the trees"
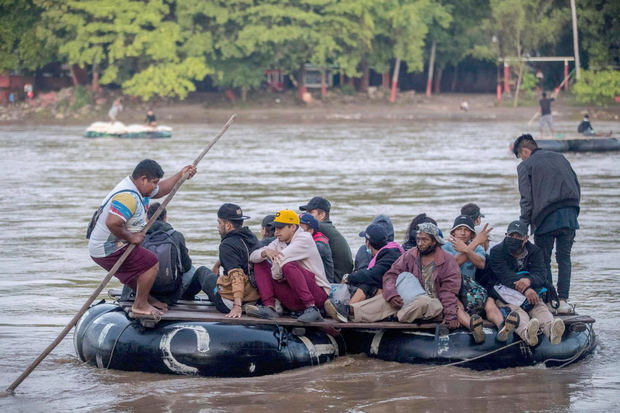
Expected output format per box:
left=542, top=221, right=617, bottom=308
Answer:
left=0, top=89, right=620, bottom=126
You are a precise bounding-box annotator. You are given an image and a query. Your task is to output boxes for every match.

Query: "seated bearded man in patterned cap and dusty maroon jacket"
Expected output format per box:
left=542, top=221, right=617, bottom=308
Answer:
left=353, top=222, right=461, bottom=328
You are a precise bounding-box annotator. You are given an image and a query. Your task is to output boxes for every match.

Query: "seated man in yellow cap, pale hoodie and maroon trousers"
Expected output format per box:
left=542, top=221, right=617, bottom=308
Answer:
left=245, top=209, right=330, bottom=323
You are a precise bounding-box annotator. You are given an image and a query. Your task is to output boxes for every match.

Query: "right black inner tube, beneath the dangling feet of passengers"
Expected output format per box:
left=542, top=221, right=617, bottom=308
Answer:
left=343, top=316, right=596, bottom=370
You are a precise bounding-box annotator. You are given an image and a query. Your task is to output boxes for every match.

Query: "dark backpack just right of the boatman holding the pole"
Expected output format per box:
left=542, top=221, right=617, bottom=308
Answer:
left=142, top=229, right=183, bottom=296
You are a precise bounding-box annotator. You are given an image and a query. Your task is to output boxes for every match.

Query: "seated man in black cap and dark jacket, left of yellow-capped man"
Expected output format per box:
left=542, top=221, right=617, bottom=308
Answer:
left=185, top=203, right=259, bottom=318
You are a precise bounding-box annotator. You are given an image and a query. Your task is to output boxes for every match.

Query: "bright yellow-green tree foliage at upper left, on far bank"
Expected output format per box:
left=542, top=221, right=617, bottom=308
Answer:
left=43, top=0, right=211, bottom=100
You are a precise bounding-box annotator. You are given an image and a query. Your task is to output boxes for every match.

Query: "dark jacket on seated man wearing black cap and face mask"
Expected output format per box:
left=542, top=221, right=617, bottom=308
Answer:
left=489, top=241, right=547, bottom=289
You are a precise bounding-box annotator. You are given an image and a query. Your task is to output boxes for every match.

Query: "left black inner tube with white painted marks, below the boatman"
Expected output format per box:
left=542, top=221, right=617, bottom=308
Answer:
left=73, top=304, right=345, bottom=377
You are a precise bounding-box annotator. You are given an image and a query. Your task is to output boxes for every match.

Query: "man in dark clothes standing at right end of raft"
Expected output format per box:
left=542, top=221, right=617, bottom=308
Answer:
left=513, top=134, right=581, bottom=313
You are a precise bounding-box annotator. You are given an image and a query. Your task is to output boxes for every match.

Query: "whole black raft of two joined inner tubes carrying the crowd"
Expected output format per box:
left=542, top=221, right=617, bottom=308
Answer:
left=74, top=291, right=596, bottom=377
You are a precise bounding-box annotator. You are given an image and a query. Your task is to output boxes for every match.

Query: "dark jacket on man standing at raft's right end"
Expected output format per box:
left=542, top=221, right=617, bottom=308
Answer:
left=517, top=149, right=581, bottom=233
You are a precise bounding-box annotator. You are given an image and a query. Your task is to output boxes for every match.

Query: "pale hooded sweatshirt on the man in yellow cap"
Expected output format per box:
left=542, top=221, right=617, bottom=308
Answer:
left=250, top=228, right=331, bottom=294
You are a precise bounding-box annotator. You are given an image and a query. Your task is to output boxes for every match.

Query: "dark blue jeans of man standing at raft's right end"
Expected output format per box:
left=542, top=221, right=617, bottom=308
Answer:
left=534, top=228, right=575, bottom=299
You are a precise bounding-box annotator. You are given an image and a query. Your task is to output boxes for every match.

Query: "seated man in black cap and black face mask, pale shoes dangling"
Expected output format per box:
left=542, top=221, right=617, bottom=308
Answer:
left=489, top=221, right=564, bottom=346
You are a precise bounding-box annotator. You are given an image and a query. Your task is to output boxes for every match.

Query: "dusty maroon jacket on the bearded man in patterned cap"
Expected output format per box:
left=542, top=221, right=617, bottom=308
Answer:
left=383, top=246, right=461, bottom=321
